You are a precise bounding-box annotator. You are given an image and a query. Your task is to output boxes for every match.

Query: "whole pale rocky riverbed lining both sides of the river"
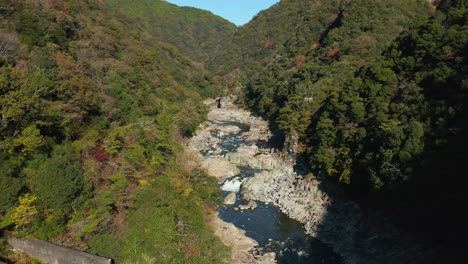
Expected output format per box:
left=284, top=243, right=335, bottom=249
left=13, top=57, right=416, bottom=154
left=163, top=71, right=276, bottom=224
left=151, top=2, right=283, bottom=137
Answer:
left=188, top=98, right=436, bottom=263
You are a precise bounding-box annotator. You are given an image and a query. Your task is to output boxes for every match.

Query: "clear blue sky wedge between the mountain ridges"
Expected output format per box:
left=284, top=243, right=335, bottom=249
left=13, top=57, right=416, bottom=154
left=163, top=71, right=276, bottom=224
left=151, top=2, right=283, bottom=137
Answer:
left=167, top=0, right=279, bottom=26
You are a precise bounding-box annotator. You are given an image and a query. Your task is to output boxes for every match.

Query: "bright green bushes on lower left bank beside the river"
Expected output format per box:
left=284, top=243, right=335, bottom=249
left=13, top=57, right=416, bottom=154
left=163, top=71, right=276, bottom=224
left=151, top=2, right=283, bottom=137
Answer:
left=89, top=175, right=229, bottom=263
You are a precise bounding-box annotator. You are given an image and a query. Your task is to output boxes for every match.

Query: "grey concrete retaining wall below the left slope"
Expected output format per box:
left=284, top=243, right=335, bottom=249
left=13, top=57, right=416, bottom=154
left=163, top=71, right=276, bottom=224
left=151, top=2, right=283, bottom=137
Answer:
left=7, top=237, right=114, bottom=264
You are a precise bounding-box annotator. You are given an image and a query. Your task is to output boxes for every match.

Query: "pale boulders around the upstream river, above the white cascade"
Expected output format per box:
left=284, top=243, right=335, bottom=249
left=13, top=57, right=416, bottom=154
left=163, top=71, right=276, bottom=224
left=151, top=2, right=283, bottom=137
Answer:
left=189, top=98, right=284, bottom=173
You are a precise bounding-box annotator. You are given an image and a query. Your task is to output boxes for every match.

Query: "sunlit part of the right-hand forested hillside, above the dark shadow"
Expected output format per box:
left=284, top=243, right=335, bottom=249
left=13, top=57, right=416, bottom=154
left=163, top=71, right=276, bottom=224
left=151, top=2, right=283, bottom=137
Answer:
left=216, top=0, right=436, bottom=186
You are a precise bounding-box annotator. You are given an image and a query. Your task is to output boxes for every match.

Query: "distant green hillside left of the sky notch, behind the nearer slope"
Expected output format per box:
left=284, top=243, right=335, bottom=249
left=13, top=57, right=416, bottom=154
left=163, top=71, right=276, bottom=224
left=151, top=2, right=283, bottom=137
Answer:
left=107, top=0, right=236, bottom=63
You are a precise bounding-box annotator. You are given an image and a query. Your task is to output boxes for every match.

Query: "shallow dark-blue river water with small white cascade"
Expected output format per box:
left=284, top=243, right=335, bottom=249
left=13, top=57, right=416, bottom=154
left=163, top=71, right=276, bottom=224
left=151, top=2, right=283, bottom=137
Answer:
left=202, top=122, right=343, bottom=264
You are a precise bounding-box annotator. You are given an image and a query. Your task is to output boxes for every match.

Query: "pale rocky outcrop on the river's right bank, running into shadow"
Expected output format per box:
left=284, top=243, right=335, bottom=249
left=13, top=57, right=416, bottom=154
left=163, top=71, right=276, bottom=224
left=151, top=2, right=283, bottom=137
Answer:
left=241, top=152, right=438, bottom=264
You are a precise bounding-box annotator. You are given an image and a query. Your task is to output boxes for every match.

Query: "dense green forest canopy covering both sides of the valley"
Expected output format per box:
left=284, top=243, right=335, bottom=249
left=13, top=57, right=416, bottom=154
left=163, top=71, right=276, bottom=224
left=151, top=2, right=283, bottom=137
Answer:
left=0, top=0, right=468, bottom=263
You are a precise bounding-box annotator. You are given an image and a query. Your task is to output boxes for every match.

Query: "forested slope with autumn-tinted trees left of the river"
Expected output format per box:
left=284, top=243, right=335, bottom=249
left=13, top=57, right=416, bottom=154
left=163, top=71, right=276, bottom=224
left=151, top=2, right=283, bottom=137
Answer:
left=0, top=0, right=227, bottom=263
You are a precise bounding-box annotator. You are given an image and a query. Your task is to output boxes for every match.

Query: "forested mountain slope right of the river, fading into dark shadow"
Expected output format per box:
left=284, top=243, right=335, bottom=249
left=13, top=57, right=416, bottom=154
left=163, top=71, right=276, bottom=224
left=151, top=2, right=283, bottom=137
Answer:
left=215, top=0, right=465, bottom=194
